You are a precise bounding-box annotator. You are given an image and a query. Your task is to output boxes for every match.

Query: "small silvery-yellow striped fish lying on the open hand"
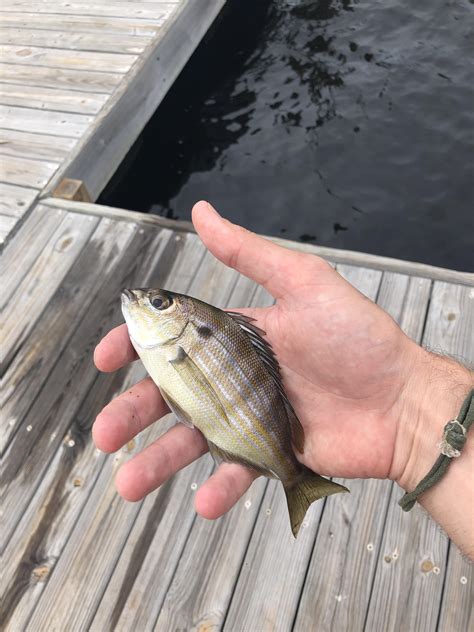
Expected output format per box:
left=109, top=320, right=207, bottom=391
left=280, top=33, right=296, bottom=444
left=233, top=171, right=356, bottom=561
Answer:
left=121, top=288, right=348, bottom=537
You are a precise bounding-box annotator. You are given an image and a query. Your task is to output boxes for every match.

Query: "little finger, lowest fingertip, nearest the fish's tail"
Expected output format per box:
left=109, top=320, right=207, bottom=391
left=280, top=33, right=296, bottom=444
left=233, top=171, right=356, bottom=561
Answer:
left=194, top=463, right=258, bottom=520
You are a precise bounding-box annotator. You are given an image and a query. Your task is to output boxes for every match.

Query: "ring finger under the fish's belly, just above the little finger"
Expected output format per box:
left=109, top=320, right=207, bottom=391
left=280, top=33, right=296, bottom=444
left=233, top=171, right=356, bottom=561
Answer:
left=115, top=424, right=207, bottom=501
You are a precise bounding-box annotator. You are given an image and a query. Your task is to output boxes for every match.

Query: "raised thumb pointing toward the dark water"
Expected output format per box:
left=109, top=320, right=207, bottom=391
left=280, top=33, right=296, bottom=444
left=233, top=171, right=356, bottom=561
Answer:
left=192, top=202, right=328, bottom=298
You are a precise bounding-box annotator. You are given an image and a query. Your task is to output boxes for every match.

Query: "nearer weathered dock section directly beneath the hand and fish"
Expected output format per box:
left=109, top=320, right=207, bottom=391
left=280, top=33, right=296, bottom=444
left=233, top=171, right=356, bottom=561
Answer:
left=0, top=199, right=474, bottom=632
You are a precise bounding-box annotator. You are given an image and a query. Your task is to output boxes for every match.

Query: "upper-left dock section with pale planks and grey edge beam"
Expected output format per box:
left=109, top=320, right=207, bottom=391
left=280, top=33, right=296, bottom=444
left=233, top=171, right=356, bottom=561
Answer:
left=0, top=0, right=225, bottom=244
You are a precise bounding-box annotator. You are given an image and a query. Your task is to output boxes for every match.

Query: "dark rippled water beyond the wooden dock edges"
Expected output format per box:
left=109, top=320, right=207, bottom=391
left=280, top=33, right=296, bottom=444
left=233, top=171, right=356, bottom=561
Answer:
left=100, top=0, right=474, bottom=270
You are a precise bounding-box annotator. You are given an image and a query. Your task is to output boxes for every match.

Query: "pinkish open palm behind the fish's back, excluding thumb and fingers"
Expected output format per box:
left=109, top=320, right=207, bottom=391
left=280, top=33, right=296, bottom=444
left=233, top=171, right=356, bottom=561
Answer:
left=244, top=260, right=412, bottom=477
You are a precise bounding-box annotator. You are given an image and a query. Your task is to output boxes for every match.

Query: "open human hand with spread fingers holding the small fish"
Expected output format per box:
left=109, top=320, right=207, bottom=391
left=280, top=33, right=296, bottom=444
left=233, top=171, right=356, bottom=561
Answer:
left=93, top=202, right=470, bottom=518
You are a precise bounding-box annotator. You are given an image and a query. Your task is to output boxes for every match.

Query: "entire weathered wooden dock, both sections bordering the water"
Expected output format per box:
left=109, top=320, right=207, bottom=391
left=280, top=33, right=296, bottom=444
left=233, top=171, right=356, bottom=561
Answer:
left=0, top=0, right=474, bottom=632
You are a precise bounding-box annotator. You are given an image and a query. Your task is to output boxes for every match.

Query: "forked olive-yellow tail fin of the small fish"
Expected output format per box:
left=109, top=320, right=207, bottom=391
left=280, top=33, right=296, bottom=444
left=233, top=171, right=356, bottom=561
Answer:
left=285, top=470, right=349, bottom=538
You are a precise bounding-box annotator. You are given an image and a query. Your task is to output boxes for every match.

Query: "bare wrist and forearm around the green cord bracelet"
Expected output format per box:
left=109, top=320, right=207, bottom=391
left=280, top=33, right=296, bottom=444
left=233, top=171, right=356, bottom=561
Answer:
left=396, top=350, right=474, bottom=559
